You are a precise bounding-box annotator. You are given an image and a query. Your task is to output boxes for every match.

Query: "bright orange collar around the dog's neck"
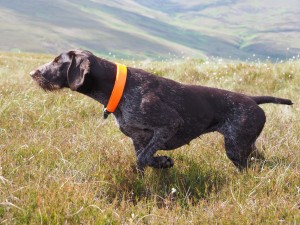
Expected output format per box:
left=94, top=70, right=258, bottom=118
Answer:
left=104, top=63, right=127, bottom=118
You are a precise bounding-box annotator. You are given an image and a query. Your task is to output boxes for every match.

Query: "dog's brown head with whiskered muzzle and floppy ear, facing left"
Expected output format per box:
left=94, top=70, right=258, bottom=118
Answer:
left=30, top=50, right=92, bottom=91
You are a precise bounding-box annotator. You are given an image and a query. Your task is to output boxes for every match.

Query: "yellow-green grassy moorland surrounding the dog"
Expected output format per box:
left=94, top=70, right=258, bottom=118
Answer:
left=0, top=53, right=300, bottom=224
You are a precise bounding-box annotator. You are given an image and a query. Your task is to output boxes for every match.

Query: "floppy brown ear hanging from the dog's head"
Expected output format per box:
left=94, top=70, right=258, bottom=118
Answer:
left=67, top=51, right=90, bottom=91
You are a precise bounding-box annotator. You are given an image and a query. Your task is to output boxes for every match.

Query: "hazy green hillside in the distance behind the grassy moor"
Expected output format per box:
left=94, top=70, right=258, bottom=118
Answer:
left=0, top=0, right=300, bottom=60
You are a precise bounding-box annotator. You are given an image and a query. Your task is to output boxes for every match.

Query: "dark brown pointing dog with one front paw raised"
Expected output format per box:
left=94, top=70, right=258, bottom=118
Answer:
left=30, top=50, right=293, bottom=171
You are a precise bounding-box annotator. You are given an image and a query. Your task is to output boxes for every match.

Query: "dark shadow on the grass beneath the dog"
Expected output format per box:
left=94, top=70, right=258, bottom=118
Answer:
left=109, top=158, right=226, bottom=206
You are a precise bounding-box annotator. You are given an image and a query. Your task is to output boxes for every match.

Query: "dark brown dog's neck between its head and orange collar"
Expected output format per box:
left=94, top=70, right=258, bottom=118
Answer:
left=77, top=56, right=117, bottom=106
